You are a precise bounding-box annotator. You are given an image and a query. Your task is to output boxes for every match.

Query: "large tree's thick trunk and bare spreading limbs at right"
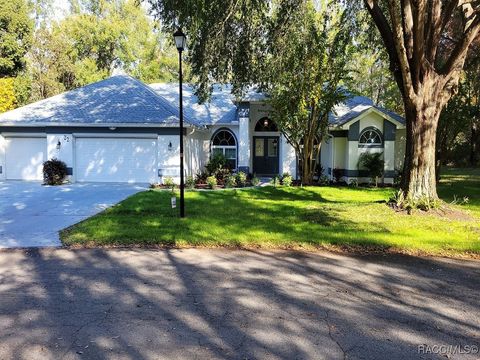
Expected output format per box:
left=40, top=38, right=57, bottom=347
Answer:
left=364, top=0, right=480, bottom=199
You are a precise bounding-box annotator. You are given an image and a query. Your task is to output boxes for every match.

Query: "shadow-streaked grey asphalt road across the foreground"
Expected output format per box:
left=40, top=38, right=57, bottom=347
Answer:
left=0, top=249, right=480, bottom=360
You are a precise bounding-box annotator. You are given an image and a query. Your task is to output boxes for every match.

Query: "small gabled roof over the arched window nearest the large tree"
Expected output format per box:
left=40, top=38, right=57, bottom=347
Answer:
left=328, top=96, right=405, bottom=126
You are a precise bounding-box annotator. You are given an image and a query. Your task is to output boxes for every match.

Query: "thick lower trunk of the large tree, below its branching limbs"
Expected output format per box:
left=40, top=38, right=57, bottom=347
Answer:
left=401, top=100, right=442, bottom=200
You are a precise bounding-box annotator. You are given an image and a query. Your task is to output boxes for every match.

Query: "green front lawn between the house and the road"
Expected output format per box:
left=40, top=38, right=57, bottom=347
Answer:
left=61, top=170, right=480, bottom=256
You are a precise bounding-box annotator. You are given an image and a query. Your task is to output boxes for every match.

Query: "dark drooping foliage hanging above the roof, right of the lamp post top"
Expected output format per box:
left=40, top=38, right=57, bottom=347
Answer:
left=146, top=0, right=270, bottom=100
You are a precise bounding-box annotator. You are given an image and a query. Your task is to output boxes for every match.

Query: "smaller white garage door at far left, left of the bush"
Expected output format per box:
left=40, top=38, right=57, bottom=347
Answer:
left=5, top=137, right=47, bottom=180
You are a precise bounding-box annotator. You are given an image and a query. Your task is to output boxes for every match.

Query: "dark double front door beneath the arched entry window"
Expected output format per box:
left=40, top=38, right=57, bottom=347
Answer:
left=253, top=136, right=279, bottom=176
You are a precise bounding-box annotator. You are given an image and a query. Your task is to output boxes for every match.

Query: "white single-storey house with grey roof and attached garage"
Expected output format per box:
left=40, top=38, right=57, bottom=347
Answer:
left=0, top=75, right=405, bottom=183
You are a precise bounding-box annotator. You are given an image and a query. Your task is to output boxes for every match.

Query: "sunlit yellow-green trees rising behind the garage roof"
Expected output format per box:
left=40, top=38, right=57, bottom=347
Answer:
left=7, top=0, right=180, bottom=106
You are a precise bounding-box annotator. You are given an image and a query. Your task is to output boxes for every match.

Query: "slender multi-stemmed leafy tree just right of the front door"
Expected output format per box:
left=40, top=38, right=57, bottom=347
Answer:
left=264, top=1, right=351, bottom=184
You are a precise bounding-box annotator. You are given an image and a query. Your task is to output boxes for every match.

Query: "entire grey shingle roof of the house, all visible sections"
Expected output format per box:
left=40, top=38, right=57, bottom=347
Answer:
left=0, top=75, right=405, bottom=126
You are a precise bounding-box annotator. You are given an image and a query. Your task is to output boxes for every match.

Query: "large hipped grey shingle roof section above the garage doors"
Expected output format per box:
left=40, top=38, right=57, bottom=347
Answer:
left=0, top=75, right=196, bottom=125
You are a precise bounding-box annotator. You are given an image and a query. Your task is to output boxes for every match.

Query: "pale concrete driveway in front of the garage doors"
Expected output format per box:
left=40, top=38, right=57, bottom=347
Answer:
left=0, top=181, right=146, bottom=248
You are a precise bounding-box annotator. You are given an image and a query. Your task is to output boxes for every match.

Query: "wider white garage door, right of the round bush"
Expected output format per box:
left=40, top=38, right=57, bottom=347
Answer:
left=75, top=138, right=157, bottom=183
